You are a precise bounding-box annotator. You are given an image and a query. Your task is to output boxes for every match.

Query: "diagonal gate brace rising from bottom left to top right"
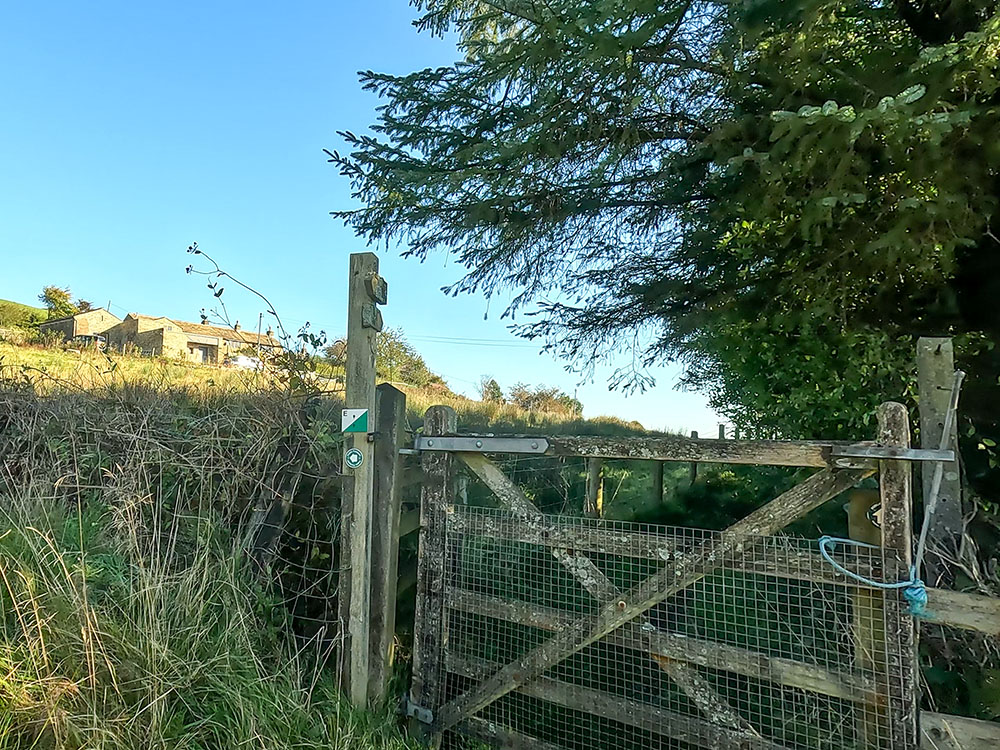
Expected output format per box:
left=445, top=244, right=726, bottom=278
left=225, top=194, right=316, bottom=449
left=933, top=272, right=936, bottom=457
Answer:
left=439, top=464, right=871, bottom=729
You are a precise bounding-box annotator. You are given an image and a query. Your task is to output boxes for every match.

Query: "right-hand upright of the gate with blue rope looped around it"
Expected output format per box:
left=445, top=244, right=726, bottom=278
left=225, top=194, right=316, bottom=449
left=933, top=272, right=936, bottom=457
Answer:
left=877, top=401, right=920, bottom=748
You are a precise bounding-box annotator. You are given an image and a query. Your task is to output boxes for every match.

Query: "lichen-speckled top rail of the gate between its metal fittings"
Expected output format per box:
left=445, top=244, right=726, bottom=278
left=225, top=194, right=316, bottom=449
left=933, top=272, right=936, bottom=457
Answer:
left=546, top=435, right=871, bottom=468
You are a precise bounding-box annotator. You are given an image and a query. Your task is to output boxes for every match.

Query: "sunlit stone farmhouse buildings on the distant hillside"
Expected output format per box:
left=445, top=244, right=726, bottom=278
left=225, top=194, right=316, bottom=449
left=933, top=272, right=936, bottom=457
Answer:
left=40, top=311, right=281, bottom=364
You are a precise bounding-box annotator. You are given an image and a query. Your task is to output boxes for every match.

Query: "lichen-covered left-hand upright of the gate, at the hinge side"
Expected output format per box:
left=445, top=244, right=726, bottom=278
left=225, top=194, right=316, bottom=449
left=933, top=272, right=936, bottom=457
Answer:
left=410, top=406, right=458, bottom=739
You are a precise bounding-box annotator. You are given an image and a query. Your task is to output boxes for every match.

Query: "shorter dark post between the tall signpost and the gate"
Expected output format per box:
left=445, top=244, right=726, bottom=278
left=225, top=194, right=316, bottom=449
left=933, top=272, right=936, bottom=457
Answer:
left=368, top=383, right=406, bottom=705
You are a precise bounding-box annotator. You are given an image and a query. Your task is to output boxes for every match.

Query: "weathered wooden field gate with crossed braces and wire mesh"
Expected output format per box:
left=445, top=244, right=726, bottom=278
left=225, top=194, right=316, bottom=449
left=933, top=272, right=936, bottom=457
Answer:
left=408, top=403, right=928, bottom=750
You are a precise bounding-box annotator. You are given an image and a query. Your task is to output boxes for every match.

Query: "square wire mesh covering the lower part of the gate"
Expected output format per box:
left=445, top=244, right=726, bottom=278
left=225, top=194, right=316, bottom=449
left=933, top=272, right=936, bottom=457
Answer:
left=435, top=506, right=915, bottom=750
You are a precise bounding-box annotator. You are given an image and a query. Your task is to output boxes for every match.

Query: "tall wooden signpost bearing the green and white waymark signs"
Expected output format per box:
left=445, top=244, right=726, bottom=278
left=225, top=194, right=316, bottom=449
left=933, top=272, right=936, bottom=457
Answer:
left=337, top=253, right=386, bottom=708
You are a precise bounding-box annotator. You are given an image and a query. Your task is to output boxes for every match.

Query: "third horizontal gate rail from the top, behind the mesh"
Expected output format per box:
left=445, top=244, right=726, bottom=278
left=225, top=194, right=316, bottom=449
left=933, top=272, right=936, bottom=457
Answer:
left=446, top=589, right=879, bottom=703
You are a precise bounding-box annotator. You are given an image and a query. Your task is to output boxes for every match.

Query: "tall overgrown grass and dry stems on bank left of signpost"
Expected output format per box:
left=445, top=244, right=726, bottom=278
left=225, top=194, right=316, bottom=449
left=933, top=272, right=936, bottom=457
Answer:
left=0, top=383, right=407, bottom=750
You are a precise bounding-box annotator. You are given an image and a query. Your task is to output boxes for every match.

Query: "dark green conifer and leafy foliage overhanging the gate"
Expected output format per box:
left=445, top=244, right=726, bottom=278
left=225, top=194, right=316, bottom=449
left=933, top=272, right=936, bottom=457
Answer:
left=331, top=0, right=1000, bottom=482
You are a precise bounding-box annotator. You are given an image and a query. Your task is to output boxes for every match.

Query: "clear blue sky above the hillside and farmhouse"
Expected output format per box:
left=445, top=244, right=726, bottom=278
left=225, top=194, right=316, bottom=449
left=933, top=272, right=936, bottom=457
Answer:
left=0, top=0, right=717, bottom=435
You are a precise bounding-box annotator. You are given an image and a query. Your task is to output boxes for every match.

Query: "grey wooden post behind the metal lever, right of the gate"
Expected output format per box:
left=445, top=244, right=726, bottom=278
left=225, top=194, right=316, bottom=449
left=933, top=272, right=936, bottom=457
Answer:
left=917, top=337, right=962, bottom=586
